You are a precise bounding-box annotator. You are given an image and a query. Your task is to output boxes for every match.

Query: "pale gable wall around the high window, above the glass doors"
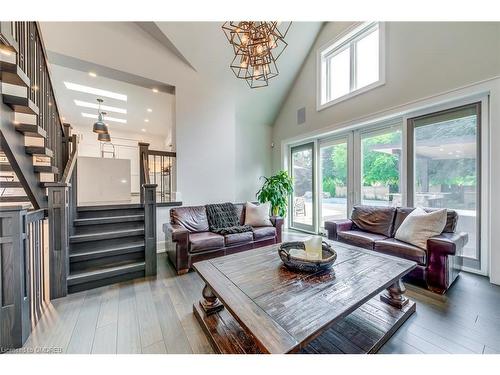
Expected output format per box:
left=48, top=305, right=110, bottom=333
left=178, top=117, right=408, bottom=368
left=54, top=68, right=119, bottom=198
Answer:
left=272, top=22, right=500, bottom=169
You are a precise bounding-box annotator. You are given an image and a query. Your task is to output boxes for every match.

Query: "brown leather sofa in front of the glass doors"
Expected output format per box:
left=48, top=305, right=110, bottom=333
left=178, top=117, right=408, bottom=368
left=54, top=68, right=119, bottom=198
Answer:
left=325, top=206, right=468, bottom=294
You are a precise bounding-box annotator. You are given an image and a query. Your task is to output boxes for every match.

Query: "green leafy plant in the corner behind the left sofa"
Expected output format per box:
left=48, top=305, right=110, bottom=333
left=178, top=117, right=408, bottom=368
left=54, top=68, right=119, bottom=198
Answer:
left=256, top=171, right=293, bottom=217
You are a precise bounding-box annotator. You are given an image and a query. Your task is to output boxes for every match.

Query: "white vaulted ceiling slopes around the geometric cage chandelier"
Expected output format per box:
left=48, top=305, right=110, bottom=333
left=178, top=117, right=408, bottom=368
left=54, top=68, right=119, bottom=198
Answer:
left=154, top=22, right=323, bottom=124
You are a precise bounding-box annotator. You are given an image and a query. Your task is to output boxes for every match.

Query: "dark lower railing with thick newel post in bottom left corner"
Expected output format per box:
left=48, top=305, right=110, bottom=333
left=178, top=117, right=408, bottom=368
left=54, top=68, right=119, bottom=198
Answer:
left=0, top=207, right=49, bottom=352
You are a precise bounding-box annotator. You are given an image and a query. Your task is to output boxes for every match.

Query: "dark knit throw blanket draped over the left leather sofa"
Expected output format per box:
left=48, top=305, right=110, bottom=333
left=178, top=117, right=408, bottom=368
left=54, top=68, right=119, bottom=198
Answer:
left=205, top=203, right=252, bottom=235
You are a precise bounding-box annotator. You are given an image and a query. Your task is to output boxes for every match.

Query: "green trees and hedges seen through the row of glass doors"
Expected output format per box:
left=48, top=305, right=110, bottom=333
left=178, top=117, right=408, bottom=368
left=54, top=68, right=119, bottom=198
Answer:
left=293, top=115, right=477, bottom=206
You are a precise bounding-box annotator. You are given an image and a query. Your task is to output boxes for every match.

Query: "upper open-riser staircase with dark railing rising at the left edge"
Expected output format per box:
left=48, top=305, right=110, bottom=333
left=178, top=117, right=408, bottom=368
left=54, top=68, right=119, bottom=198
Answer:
left=0, top=22, right=63, bottom=209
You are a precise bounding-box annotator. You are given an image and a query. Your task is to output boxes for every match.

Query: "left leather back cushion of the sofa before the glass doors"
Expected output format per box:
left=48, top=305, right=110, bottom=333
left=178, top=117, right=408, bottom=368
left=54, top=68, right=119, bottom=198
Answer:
left=351, top=206, right=396, bottom=237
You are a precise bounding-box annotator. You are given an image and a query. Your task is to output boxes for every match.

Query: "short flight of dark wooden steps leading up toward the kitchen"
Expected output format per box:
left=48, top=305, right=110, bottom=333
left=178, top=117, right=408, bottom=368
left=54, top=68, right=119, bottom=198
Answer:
left=68, top=204, right=145, bottom=293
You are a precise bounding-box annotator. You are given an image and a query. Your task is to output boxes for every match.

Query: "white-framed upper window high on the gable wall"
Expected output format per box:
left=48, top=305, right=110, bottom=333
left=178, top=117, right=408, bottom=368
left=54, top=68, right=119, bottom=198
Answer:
left=318, top=22, right=384, bottom=109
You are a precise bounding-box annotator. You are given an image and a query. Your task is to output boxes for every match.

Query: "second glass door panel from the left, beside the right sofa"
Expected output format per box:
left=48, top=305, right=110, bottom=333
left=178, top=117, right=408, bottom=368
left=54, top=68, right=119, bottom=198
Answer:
left=319, top=137, right=349, bottom=228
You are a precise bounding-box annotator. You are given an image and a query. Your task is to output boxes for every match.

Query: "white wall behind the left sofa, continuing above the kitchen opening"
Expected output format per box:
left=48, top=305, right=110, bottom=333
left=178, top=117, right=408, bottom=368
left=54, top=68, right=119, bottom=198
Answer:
left=42, top=22, right=270, bottom=204
